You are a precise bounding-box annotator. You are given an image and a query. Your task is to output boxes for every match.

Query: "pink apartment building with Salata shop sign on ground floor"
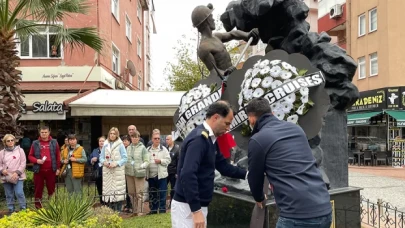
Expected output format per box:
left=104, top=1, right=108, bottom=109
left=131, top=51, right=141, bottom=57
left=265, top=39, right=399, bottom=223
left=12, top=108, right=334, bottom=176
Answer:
left=17, top=0, right=156, bottom=150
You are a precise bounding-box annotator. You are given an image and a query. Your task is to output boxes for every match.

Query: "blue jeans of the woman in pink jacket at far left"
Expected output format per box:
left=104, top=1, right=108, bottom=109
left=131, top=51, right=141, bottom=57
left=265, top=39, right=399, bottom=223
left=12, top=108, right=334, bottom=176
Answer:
left=3, top=180, right=27, bottom=212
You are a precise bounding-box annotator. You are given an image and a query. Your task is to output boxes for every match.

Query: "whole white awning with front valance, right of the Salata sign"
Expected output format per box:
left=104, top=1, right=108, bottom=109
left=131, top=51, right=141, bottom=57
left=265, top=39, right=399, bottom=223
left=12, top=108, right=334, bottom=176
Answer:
left=69, top=89, right=185, bottom=117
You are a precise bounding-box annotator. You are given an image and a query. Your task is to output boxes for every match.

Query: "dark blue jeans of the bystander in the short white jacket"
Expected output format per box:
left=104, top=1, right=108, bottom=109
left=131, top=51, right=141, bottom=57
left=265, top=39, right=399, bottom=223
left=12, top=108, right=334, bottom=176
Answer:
left=148, top=177, right=167, bottom=213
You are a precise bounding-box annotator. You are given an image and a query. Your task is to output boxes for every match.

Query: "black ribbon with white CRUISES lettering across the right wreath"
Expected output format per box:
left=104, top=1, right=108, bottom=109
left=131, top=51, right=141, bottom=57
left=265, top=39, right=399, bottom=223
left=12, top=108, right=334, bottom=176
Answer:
left=230, top=71, right=325, bottom=131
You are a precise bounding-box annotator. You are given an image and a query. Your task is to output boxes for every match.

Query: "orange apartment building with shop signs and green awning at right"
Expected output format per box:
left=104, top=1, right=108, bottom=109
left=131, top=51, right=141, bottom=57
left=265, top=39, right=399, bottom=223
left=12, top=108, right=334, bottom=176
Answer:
left=318, top=0, right=405, bottom=146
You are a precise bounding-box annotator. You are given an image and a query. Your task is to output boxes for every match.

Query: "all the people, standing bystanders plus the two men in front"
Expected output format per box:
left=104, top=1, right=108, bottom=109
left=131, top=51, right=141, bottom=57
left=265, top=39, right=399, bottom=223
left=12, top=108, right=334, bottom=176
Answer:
left=0, top=98, right=332, bottom=228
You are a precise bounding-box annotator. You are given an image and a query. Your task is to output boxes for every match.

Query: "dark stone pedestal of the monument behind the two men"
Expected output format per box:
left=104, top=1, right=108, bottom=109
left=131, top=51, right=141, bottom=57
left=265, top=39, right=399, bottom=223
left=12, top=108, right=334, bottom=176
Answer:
left=207, top=187, right=361, bottom=228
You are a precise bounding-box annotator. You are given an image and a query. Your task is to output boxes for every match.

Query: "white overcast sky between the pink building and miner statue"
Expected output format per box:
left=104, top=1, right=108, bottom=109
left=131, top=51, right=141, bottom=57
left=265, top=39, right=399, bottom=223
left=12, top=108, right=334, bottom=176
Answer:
left=151, top=0, right=231, bottom=87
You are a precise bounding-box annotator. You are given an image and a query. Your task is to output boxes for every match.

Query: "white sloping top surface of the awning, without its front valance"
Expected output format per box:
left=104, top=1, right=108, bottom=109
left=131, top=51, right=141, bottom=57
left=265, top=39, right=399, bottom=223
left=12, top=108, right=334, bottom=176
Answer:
left=69, top=89, right=185, bottom=107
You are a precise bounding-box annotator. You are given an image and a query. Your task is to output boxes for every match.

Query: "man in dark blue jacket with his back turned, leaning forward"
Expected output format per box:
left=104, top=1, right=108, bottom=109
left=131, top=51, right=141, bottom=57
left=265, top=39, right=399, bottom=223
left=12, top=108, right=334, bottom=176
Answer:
left=246, top=98, right=332, bottom=228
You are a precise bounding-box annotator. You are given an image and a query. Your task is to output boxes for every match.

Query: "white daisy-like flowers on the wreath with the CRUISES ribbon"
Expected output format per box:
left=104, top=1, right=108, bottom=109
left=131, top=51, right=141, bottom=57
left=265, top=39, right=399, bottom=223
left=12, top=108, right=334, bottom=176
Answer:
left=238, top=59, right=314, bottom=124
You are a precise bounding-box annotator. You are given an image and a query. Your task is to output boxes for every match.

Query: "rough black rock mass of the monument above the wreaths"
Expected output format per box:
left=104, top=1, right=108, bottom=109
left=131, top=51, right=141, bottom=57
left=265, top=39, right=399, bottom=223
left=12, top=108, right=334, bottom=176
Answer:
left=221, top=0, right=359, bottom=110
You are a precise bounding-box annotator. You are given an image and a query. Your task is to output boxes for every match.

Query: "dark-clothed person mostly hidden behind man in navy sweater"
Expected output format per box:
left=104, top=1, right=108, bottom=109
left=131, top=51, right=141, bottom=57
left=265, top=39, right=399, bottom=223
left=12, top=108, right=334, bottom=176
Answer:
left=166, top=135, right=180, bottom=208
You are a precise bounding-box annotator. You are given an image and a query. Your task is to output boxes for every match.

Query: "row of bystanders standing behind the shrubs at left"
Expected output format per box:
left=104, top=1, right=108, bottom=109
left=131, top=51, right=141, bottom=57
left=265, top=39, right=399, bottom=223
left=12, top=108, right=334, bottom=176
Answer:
left=0, top=125, right=180, bottom=215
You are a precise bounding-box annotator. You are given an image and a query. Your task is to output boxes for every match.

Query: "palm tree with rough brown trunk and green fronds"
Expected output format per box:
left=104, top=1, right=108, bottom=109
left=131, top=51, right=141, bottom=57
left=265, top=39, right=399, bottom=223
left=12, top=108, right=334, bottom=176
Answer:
left=0, top=0, right=104, bottom=141
